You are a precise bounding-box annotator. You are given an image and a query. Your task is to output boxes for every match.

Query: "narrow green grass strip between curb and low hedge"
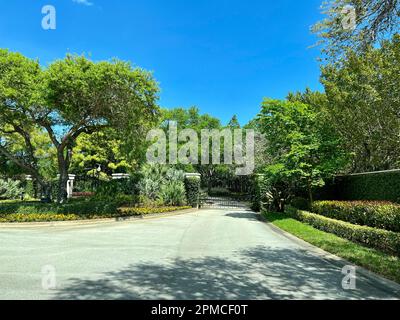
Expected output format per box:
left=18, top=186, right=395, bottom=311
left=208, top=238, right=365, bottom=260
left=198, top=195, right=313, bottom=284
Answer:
left=263, top=212, right=400, bottom=283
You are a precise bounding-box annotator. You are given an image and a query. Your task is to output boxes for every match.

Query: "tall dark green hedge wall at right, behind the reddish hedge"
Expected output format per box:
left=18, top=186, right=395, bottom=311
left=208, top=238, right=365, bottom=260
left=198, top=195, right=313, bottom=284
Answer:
left=335, top=170, right=400, bottom=203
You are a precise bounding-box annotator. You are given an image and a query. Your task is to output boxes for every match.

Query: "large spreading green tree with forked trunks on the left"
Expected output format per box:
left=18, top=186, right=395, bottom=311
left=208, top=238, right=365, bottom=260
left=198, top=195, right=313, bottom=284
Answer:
left=0, top=50, right=158, bottom=202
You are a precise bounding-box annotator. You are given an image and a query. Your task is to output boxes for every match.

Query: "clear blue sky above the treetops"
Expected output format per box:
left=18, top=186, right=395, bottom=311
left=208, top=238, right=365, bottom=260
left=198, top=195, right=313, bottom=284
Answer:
left=0, top=0, right=322, bottom=124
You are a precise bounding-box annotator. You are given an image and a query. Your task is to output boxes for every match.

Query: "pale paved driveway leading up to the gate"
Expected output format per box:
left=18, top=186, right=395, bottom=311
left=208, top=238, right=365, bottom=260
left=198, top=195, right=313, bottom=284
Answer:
left=0, top=209, right=399, bottom=299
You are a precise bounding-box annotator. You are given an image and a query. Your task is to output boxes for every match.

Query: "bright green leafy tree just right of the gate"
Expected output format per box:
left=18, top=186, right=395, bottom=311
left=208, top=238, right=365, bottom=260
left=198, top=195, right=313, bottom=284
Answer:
left=257, top=99, right=346, bottom=206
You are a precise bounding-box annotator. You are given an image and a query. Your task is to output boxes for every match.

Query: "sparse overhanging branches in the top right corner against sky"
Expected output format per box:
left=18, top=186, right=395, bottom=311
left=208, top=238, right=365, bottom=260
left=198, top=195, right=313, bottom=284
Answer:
left=313, top=0, right=400, bottom=59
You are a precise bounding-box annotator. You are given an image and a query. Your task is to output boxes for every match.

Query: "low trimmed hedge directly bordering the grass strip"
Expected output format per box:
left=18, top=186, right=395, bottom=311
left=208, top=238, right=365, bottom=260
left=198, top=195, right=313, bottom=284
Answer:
left=285, top=206, right=400, bottom=256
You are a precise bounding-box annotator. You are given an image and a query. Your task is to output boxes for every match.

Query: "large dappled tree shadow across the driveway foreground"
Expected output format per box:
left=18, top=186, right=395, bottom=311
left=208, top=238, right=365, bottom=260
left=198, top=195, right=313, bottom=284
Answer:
left=49, top=246, right=393, bottom=300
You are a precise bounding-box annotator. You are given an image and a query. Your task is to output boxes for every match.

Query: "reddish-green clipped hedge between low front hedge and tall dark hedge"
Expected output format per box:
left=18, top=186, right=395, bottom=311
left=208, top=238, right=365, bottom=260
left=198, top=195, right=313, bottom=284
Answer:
left=312, top=201, right=400, bottom=232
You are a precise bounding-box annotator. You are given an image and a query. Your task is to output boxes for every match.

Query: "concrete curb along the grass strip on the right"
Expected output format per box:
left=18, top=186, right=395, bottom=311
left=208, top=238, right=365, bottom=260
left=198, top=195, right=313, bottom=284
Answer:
left=259, top=213, right=400, bottom=299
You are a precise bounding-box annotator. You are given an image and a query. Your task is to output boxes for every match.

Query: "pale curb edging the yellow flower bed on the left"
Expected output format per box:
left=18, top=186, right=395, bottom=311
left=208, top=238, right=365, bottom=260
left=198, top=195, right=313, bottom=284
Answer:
left=0, top=209, right=199, bottom=229
